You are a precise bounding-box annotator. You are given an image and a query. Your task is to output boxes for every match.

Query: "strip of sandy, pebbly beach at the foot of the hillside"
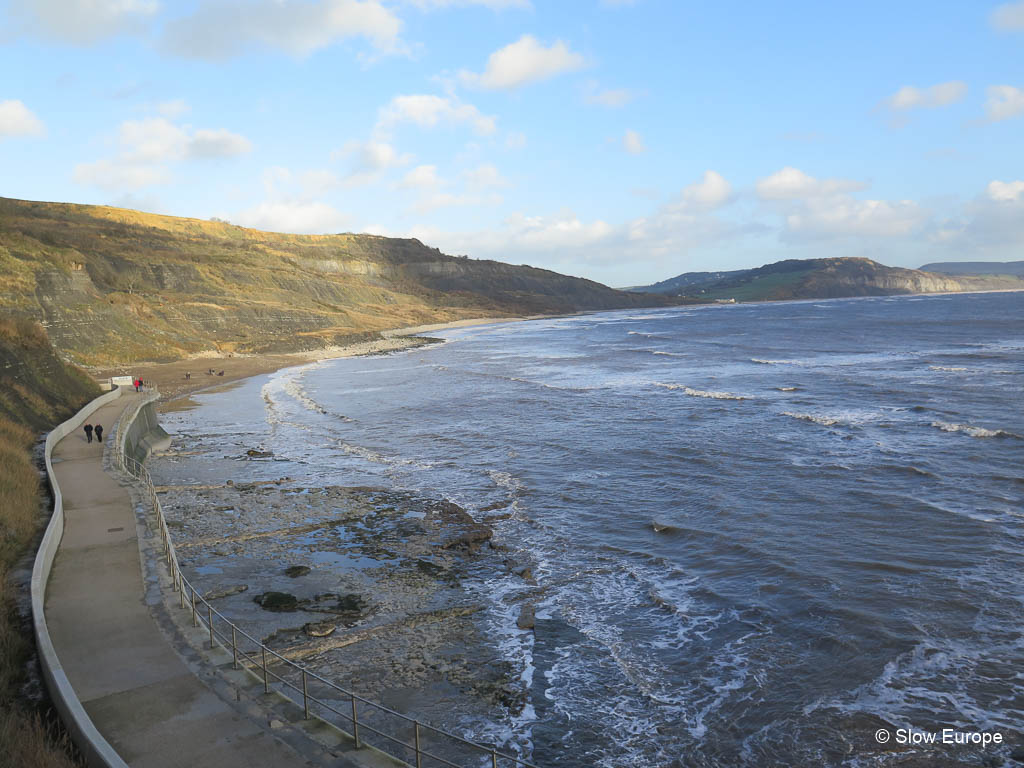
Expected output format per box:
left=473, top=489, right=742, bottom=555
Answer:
left=90, top=314, right=544, bottom=409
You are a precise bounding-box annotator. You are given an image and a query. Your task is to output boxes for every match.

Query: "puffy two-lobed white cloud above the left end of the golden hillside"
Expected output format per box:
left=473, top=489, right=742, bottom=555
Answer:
left=73, top=118, right=253, bottom=189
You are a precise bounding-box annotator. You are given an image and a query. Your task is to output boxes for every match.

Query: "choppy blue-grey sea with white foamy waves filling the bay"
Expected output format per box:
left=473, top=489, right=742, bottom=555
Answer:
left=148, top=293, right=1024, bottom=767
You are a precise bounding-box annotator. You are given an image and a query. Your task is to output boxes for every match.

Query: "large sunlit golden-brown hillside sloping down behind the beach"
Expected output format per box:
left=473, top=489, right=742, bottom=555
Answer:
left=0, top=198, right=673, bottom=366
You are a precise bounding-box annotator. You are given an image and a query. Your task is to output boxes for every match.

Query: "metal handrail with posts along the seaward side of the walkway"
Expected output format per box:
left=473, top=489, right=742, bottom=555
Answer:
left=114, top=389, right=538, bottom=768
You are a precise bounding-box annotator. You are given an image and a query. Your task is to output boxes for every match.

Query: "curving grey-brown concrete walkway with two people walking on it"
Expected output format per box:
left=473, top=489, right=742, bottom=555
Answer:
left=46, top=392, right=313, bottom=768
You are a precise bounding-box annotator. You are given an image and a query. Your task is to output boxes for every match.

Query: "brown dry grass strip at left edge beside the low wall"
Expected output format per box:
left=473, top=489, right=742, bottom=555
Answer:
left=0, top=419, right=77, bottom=768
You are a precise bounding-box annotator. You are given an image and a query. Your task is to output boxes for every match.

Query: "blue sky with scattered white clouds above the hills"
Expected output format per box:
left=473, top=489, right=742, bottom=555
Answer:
left=0, top=0, right=1024, bottom=286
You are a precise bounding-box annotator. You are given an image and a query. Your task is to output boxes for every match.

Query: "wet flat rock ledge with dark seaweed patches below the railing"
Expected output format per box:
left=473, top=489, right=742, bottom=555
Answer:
left=158, top=473, right=532, bottom=728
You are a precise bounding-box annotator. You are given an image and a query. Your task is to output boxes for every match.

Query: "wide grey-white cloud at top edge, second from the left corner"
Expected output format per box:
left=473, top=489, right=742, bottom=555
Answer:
left=163, top=0, right=402, bottom=59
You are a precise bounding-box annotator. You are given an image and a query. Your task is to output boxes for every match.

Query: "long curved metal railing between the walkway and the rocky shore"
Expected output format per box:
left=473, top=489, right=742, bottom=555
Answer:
left=114, top=389, right=538, bottom=768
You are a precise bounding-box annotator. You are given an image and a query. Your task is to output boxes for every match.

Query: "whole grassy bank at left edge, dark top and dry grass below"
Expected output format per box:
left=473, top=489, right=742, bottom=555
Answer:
left=0, top=317, right=98, bottom=768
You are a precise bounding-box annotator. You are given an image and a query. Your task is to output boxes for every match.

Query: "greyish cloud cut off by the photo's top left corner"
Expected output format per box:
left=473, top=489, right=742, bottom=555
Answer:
left=8, top=0, right=160, bottom=45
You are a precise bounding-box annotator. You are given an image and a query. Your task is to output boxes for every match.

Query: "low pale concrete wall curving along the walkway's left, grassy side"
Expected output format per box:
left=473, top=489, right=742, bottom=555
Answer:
left=31, top=387, right=128, bottom=768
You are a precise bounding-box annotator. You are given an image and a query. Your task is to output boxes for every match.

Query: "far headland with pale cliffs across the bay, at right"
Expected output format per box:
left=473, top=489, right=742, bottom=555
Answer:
left=631, top=258, right=1024, bottom=301
